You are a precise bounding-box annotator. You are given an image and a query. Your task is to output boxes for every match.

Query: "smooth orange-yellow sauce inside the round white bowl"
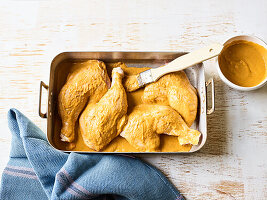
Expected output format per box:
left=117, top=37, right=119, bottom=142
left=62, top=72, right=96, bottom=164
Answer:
left=219, top=40, right=267, bottom=87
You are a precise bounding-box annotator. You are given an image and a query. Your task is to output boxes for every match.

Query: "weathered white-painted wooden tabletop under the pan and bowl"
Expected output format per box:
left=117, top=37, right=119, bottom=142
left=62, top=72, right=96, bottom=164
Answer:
left=0, top=0, right=267, bottom=199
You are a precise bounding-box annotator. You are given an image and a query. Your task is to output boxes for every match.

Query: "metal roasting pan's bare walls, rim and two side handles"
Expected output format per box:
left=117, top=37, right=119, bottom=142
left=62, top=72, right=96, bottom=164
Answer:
left=39, top=52, right=215, bottom=154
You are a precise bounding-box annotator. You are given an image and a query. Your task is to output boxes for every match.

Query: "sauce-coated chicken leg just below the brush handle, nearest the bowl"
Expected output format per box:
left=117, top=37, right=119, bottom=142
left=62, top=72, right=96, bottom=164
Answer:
left=142, top=71, right=198, bottom=127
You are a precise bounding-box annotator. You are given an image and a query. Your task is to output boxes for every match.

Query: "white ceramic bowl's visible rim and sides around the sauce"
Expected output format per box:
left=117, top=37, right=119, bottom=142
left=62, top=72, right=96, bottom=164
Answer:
left=216, top=35, right=267, bottom=91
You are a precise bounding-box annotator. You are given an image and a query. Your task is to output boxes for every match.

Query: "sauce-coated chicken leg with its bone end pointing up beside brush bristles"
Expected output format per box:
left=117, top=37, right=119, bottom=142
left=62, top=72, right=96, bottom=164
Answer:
left=79, top=67, right=128, bottom=151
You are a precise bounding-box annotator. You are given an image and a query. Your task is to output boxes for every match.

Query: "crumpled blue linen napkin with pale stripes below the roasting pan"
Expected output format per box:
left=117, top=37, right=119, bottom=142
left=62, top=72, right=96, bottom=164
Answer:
left=0, top=109, right=184, bottom=200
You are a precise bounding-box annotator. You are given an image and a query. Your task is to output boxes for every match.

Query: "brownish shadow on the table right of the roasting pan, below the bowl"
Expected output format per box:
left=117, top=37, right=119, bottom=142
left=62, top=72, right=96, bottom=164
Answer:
left=199, top=78, right=267, bottom=155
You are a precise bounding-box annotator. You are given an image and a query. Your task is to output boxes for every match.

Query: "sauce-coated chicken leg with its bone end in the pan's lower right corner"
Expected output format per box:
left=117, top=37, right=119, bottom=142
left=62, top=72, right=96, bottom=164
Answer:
left=120, top=104, right=201, bottom=152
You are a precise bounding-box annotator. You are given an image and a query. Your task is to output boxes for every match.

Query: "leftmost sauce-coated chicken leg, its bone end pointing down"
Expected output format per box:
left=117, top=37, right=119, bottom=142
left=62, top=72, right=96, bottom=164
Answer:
left=58, top=60, right=110, bottom=142
